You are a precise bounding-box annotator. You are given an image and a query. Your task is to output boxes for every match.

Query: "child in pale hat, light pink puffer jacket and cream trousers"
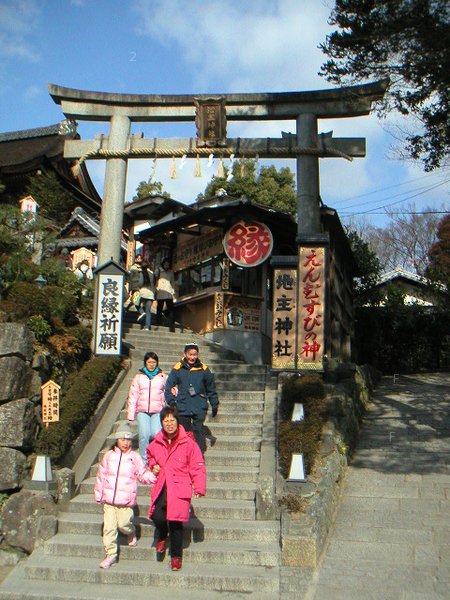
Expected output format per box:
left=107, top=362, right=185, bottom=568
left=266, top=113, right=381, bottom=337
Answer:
left=94, top=424, right=156, bottom=569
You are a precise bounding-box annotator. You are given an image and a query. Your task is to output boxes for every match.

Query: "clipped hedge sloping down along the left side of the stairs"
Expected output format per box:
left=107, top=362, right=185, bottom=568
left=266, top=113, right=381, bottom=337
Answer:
left=36, top=356, right=121, bottom=464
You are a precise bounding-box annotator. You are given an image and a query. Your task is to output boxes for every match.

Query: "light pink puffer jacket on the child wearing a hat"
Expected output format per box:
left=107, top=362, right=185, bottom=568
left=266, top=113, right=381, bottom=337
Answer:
left=94, top=446, right=156, bottom=506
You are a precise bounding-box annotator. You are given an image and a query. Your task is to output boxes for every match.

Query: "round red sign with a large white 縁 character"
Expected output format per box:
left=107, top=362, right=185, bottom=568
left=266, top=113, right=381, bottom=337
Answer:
left=223, top=221, right=273, bottom=267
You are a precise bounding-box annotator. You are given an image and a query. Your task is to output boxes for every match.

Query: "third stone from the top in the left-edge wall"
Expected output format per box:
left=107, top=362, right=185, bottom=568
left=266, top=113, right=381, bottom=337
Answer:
left=0, top=398, right=39, bottom=449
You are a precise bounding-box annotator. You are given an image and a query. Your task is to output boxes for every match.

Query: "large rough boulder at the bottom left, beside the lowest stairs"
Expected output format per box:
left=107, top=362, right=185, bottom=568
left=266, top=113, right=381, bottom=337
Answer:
left=2, top=490, right=57, bottom=554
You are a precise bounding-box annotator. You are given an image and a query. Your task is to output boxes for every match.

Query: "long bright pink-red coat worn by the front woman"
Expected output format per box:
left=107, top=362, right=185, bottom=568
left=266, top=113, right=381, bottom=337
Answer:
left=147, top=425, right=206, bottom=522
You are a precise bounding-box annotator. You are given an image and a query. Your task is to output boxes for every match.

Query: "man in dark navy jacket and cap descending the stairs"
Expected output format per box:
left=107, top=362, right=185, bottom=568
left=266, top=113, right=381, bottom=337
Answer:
left=164, top=343, right=219, bottom=454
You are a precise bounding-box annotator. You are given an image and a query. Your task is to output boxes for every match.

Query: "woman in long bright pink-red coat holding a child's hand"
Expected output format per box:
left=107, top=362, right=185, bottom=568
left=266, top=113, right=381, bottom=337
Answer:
left=147, top=406, right=206, bottom=571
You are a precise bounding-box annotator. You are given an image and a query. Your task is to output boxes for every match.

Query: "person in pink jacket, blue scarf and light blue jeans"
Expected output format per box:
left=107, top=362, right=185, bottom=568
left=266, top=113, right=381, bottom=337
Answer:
left=127, top=352, right=167, bottom=462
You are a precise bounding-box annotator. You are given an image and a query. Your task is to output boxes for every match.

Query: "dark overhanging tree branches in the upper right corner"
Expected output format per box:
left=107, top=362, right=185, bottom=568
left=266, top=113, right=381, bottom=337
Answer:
left=320, top=0, right=450, bottom=170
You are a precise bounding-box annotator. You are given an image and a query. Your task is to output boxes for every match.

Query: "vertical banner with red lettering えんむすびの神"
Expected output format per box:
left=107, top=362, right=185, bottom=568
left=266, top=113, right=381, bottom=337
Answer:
left=297, top=246, right=326, bottom=371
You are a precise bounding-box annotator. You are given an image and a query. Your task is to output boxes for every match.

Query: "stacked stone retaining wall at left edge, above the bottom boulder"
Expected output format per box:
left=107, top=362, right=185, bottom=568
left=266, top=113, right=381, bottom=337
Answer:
left=0, top=323, right=41, bottom=491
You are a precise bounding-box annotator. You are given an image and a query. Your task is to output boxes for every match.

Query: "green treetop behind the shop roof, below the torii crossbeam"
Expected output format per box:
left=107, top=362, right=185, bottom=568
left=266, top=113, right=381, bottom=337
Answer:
left=197, top=159, right=297, bottom=214
